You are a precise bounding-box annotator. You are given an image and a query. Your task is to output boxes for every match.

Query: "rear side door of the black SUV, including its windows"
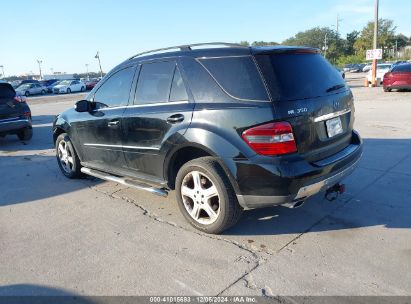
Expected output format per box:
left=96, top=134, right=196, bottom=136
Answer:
left=123, top=60, right=194, bottom=180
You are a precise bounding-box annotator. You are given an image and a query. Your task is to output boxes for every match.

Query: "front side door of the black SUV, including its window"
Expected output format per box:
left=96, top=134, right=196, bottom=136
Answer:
left=73, top=66, right=135, bottom=172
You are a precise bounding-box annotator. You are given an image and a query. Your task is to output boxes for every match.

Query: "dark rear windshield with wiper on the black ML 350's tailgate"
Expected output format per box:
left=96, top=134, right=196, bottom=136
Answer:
left=256, top=53, right=346, bottom=100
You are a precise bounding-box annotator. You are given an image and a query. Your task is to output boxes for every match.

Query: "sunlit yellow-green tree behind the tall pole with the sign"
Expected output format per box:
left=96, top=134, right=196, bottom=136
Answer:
left=354, top=19, right=397, bottom=57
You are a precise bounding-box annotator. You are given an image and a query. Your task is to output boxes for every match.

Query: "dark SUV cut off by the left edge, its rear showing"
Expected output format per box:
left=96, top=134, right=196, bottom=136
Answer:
left=0, top=83, right=33, bottom=140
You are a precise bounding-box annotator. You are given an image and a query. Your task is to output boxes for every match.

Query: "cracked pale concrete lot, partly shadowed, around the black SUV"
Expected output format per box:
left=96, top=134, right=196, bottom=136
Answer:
left=0, top=74, right=411, bottom=296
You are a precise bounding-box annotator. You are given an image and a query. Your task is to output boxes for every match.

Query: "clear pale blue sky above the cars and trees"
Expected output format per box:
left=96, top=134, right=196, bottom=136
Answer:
left=0, top=0, right=411, bottom=76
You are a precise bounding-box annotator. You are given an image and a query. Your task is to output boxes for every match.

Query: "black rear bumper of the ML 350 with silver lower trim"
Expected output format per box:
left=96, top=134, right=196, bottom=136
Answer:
left=232, top=132, right=362, bottom=209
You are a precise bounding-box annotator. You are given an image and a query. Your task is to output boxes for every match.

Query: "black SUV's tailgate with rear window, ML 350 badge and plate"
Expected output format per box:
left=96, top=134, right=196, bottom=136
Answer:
left=255, top=49, right=354, bottom=161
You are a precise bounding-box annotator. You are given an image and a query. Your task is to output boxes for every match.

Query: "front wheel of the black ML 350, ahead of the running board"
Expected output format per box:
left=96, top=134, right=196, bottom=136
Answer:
left=55, top=133, right=83, bottom=178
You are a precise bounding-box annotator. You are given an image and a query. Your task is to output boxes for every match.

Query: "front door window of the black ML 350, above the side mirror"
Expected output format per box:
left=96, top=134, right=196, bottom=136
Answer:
left=94, top=67, right=134, bottom=107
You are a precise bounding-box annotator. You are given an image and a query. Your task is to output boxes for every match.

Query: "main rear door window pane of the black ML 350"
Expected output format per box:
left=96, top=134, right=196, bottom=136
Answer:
left=134, top=61, right=176, bottom=104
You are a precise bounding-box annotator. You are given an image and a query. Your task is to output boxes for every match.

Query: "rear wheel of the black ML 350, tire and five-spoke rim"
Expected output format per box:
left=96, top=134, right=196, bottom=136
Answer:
left=176, top=157, right=243, bottom=234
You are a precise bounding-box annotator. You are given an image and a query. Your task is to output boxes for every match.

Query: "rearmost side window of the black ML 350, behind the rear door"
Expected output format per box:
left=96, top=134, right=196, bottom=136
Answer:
left=200, top=56, right=269, bottom=100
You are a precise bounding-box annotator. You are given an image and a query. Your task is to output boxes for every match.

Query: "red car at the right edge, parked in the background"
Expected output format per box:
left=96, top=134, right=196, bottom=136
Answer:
left=383, top=63, right=411, bottom=92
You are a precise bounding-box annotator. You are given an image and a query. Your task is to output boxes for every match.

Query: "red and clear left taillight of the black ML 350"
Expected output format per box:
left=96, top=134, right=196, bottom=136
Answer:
left=242, top=122, right=297, bottom=155
